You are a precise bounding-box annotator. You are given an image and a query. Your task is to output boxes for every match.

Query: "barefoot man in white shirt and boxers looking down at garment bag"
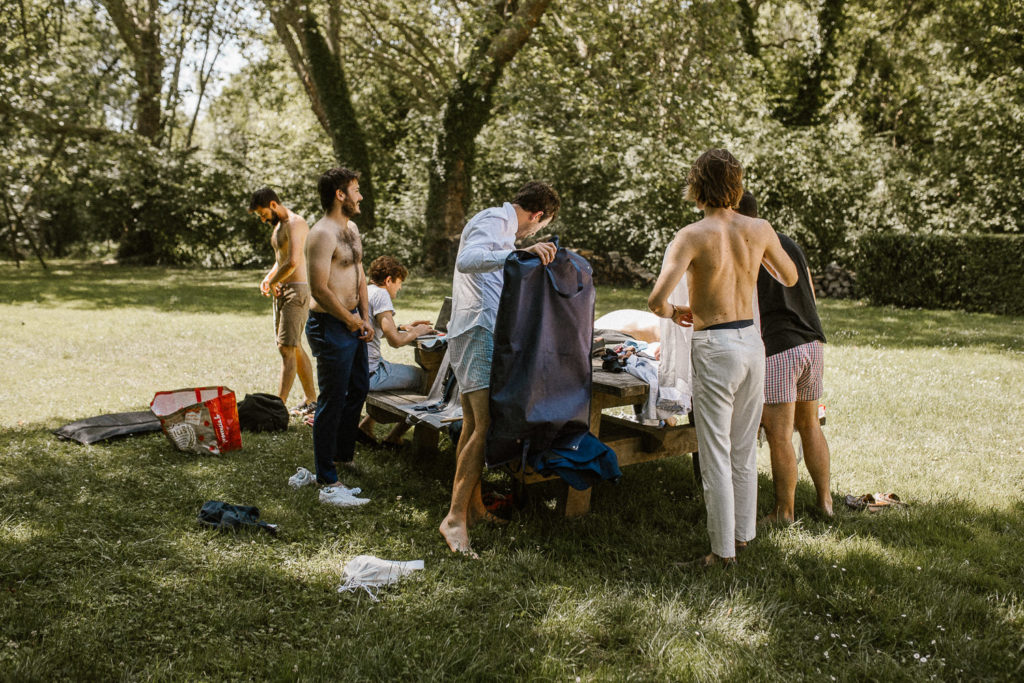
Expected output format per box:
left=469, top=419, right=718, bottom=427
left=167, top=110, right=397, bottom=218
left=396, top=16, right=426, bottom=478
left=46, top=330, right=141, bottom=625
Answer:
left=439, top=182, right=560, bottom=555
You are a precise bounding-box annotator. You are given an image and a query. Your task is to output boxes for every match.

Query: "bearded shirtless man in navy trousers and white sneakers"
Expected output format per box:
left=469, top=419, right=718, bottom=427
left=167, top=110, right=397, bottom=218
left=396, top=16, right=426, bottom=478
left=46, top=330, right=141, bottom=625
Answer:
left=306, top=168, right=374, bottom=505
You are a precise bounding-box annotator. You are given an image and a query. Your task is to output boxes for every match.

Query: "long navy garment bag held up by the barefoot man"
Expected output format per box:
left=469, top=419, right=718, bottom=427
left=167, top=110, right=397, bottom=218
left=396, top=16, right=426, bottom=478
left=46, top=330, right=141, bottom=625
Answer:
left=486, top=240, right=595, bottom=467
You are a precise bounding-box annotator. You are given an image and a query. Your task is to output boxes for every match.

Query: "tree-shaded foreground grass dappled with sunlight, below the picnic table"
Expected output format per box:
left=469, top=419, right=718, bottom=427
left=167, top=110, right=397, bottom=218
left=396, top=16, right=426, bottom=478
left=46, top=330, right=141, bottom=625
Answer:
left=0, top=427, right=1024, bottom=680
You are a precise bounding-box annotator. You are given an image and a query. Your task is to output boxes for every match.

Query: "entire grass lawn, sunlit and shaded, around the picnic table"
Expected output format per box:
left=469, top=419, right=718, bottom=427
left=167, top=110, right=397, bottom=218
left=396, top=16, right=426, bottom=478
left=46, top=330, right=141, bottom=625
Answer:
left=0, top=264, right=1024, bottom=681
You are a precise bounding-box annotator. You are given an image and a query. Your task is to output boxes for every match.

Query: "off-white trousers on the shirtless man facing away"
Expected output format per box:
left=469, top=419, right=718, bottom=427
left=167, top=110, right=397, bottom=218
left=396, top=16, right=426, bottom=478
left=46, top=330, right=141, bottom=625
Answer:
left=690, top=325, right=765, bottom=557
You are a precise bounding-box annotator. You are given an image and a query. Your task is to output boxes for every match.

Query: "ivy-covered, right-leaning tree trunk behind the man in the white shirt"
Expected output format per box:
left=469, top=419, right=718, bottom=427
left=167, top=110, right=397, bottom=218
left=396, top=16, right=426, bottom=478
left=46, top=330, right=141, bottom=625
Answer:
left=423, top=0, right=551, bottom=272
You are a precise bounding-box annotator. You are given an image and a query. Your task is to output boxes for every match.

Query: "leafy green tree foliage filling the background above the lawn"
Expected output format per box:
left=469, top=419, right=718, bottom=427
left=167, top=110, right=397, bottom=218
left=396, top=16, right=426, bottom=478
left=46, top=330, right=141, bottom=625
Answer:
left=0, top=0, right=1024, bottom=294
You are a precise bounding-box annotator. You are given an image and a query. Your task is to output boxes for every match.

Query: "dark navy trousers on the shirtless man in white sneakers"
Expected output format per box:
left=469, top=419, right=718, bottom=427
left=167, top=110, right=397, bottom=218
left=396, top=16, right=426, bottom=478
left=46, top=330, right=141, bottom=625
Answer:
left=306, top=310, right=370, bottom=484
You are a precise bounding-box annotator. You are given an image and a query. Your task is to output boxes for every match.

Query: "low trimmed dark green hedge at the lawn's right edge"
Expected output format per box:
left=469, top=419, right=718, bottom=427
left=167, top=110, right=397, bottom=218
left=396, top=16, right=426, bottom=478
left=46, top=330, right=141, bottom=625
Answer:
left=856, top=232, right=1024, bottom=315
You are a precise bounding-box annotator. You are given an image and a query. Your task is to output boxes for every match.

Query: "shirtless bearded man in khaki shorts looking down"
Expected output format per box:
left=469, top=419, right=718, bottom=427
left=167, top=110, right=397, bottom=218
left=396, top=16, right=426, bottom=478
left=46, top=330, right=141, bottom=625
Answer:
left=249, top=187, right=316, bottom=415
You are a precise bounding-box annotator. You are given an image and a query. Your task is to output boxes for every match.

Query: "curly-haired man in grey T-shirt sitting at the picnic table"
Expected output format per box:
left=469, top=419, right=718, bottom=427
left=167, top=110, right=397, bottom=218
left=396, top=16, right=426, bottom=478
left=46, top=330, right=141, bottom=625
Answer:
left=359, top=256, right=433, bottom=447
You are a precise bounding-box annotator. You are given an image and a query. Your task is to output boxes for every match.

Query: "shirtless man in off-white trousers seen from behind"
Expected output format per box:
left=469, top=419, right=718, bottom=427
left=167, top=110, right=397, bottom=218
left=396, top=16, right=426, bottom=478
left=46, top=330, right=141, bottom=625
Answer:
left=647, top=150, right=797, bottom=566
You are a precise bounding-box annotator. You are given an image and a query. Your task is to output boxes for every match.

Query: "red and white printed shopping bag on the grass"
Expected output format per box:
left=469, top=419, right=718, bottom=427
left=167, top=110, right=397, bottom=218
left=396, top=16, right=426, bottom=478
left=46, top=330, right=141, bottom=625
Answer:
left=150, top=387, right=242, bottom=455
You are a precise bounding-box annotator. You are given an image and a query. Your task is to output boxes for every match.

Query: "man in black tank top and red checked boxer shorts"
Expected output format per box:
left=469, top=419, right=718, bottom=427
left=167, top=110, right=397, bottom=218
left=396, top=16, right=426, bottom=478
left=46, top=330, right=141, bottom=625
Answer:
left=738, top=193, right=833, bottom=523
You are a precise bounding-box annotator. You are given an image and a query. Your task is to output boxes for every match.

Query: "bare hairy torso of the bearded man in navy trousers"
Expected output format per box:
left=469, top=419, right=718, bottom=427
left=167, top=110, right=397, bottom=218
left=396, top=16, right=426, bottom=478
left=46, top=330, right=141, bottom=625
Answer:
left=306, top=216, right=362, bottom=313
